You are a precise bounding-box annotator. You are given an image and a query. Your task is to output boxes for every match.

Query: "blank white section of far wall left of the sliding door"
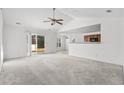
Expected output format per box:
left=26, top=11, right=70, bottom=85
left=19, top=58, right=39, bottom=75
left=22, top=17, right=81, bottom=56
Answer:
left=4, top=25, right=27, bottom=59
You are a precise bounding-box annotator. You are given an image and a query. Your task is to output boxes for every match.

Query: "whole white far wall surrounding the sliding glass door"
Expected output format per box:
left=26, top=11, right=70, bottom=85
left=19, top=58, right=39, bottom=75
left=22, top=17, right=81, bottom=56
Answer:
left=4, top=25, right=56, bottom=59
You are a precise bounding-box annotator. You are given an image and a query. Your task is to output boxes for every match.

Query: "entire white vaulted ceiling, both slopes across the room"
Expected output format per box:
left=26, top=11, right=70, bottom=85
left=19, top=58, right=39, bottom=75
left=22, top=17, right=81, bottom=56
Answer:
left=3, top=8, right=124, bottom=30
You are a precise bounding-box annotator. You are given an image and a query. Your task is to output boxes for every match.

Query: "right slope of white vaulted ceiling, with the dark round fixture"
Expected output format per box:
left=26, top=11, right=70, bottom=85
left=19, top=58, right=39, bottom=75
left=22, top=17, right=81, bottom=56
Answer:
left=58, top=8, right=124, bottom=18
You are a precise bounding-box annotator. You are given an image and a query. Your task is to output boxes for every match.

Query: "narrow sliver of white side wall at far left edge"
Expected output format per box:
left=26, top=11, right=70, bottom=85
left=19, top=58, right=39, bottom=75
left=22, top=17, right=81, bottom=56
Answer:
left=0, top=9, right=3, bottom=69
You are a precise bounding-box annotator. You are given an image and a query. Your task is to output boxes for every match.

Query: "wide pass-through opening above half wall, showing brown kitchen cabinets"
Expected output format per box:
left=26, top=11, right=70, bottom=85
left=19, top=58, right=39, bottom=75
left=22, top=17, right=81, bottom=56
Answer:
left=59, top=24, right=101, bottom=44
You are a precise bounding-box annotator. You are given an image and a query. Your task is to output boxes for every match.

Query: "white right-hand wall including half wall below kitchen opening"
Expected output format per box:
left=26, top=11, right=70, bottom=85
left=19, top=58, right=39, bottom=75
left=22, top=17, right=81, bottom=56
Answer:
left=69, top=18, right=124, bottom=64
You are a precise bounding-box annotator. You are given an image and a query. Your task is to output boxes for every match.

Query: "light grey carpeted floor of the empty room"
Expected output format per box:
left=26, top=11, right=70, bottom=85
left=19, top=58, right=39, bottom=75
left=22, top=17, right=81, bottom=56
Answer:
left=0, top=53, right=123, bottom=85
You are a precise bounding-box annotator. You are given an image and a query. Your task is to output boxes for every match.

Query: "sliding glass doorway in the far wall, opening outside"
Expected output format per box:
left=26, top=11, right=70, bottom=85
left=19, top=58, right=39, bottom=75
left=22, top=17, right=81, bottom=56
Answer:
left=31, top=34, right=45, bottom=55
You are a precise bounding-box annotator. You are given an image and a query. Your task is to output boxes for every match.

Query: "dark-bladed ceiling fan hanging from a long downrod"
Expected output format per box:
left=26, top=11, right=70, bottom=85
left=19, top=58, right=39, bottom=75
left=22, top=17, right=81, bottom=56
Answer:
left=43, top=8, right=63, bottom=25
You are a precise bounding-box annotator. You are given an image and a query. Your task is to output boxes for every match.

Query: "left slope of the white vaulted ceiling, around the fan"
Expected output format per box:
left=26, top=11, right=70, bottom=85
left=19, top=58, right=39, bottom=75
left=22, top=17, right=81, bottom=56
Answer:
left=2, top=8, right=72, bottom=30
